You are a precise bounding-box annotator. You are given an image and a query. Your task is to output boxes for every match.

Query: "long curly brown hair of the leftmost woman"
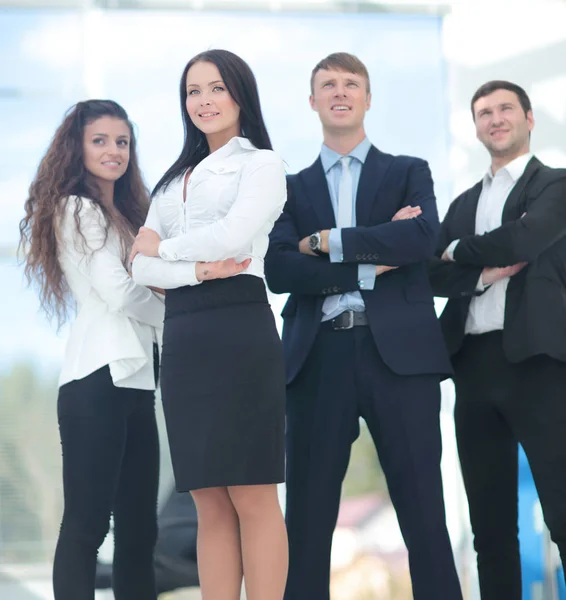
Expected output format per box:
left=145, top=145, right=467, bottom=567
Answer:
left=19, top=100, right=149, bottom=327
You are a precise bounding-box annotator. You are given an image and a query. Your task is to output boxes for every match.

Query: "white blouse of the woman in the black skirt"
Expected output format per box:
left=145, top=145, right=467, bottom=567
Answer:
left=132, top=137, right=287, bottom=289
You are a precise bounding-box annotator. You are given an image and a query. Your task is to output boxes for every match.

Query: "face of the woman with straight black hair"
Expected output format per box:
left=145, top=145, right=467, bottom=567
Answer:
left=186, top=62, right=240, bottom=144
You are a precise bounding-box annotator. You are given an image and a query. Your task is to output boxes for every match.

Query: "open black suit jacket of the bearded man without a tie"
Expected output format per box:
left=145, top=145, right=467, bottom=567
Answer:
left=429, top=158, right=566, bottom=362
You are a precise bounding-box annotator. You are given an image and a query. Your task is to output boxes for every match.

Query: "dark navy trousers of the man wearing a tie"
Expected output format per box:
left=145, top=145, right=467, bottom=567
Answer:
left=285, top=324, right=462, bottom=600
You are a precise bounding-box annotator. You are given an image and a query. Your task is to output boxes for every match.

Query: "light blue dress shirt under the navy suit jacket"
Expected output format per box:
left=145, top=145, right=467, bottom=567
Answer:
left=320, top=138, right=376, bottom=321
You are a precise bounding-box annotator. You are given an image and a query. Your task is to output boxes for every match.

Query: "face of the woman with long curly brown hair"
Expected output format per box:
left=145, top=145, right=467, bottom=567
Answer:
left=83, top=117, right=131, bottom=182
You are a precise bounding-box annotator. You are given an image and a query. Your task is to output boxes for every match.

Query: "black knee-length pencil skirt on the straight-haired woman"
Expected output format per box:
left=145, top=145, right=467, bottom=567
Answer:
left=161, top=275, right=285, bottom=492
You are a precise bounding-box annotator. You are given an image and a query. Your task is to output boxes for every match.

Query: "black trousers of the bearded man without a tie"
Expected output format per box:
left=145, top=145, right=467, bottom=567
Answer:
left=453, top=331, right=566, bottom=600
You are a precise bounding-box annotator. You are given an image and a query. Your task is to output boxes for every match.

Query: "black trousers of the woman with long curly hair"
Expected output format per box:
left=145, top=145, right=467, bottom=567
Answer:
left=53, top=367, right=159, bottom=600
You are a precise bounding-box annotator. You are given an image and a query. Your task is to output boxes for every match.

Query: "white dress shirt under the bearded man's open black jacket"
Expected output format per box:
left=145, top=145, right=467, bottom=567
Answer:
left=449, top=153, right=533, bottom=335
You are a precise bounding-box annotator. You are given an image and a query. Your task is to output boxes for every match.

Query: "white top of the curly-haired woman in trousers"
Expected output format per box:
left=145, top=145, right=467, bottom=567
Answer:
left=57, top=197, right=164, bottom=390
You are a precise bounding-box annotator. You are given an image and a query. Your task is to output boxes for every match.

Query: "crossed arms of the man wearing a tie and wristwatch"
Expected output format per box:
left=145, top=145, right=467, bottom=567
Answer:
left=265, top=160, right=439, bottom=295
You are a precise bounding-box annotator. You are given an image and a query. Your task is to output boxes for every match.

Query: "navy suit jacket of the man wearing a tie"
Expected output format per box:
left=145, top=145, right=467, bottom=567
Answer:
left=265, top=147, right=451, bottom=383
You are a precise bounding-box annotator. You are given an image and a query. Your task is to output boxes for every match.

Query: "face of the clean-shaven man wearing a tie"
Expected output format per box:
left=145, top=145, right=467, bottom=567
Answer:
left=310, top=69, right=371, bottom=133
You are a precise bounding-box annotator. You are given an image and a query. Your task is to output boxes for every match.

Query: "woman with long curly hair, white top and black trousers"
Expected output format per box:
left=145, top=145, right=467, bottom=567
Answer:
left=20, top=100, right=163, bottom=600
